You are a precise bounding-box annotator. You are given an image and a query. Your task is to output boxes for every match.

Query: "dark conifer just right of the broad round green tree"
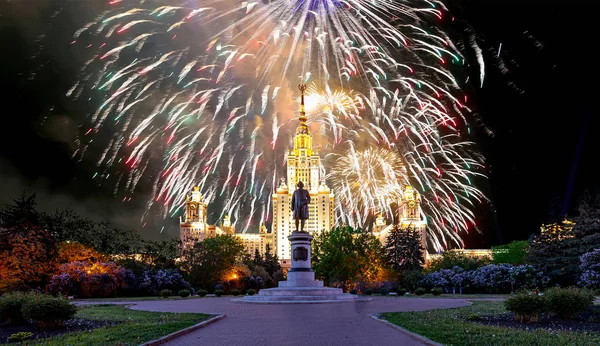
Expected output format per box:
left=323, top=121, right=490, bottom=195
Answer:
left=384, top=225, right=425, bottom=271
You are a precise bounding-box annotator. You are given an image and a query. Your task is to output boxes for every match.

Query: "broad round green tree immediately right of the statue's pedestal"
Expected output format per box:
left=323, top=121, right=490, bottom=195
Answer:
left=312, top=226, right=385, bottom=289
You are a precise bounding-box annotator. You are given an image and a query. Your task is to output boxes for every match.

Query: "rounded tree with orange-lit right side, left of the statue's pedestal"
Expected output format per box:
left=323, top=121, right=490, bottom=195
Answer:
left=182, top=235, right=246, bottom=290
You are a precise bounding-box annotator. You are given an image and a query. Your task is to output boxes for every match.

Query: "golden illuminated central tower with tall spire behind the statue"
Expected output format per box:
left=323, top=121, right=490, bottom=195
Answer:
left=271, top=84, right=334, bottom=267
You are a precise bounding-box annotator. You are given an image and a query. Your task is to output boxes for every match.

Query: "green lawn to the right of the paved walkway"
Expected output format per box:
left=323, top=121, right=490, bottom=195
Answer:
left=381, top=301, right=600, bottom=346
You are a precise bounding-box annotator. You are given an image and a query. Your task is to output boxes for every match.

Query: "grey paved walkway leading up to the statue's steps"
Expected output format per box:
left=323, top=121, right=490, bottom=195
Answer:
left=82, top=297, right=469, bottom=346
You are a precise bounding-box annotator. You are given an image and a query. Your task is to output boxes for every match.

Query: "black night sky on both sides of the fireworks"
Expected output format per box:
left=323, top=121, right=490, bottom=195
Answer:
left=0, top=0, right=600, bottom=248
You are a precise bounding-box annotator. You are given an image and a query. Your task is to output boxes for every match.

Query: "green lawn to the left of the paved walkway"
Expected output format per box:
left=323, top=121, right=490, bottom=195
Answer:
left=27, top=305, right=212, bottom=346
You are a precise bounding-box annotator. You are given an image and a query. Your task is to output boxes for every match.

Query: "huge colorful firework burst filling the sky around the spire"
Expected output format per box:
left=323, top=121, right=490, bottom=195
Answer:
left=68, top=0, right=484, bottom=248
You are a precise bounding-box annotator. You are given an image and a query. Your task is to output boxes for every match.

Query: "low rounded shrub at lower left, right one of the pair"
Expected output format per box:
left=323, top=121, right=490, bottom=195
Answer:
left=21, top=294, right=77, bottom=328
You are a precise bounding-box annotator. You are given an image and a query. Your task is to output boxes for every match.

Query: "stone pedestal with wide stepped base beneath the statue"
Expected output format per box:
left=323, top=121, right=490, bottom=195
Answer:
left=233, top=232, right=371, bottom=304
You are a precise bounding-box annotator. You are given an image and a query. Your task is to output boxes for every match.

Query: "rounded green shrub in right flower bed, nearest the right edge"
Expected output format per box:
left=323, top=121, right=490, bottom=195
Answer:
left=545, top=287, right=594, bottom=318
